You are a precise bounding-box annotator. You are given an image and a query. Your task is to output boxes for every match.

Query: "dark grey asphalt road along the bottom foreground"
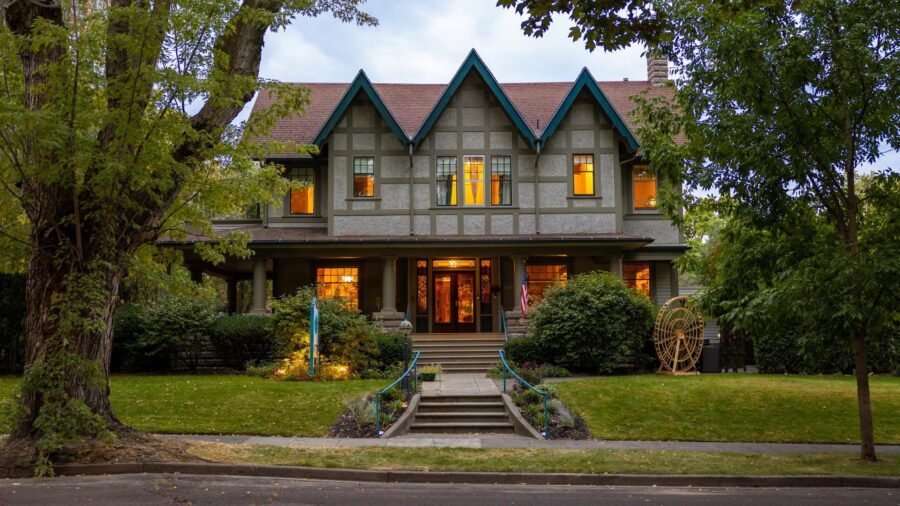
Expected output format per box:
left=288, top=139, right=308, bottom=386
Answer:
left=0, top=474, right=900, bottom=506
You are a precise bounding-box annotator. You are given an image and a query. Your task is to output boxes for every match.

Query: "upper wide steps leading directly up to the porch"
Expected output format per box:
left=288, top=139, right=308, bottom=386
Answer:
left=412, top=333, right=505, bottom=373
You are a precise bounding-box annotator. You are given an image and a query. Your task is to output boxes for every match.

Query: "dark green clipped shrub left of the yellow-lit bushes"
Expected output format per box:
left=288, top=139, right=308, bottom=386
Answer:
left=210, top=315, right=275, bottom=368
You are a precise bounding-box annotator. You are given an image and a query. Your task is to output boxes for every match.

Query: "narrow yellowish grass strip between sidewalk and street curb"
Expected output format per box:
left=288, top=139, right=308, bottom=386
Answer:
left=190, top=443, right=900, bottom=476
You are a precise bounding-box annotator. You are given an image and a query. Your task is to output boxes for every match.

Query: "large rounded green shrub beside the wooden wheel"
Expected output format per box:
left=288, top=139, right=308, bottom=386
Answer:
left=517, top=272, right=654, bottom=374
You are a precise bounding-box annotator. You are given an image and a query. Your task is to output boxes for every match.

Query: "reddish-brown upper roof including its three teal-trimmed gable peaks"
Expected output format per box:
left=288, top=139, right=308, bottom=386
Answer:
left=253, top=50, right=672, bottom=158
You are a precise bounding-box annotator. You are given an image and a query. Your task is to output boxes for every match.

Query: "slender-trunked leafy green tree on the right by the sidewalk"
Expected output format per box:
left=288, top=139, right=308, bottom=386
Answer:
left=510, top=0, right=900, bottom=460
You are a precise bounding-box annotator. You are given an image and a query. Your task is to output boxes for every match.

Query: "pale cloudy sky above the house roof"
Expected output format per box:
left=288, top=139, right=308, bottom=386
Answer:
left=243, top=0, right=900, bottom=171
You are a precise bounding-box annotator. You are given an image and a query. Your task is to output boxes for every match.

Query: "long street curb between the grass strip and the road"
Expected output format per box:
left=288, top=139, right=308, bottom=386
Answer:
left=0, top=462, right=900, bottom=489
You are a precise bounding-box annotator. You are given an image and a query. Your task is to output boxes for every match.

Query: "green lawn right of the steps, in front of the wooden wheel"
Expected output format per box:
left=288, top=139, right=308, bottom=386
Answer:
left=555, top=374, right=900, bottom=444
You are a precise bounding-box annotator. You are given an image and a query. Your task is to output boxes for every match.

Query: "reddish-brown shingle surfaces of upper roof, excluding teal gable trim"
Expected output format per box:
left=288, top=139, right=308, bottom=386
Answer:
left=253, top=81, right=672, bottom=148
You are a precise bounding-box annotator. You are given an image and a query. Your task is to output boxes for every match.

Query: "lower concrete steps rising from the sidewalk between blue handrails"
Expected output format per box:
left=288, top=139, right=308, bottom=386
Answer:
left=409, top=395, right=515, bottom=434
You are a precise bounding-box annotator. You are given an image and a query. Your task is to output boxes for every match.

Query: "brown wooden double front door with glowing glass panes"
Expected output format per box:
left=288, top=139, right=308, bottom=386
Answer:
left=433, top=271, right=476, bottom=332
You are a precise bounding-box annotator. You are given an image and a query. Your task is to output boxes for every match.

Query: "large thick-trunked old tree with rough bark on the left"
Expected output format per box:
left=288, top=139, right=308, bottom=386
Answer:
left=0, top=0, right=375, bottom=471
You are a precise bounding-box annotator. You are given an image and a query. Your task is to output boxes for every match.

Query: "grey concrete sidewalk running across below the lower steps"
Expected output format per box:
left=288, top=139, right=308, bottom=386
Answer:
left=160, top=434, right=900, bottom=455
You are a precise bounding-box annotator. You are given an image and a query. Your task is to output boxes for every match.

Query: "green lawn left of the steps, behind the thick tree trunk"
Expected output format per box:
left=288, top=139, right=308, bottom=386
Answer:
left=0, top=375, right=388, bottom=437
